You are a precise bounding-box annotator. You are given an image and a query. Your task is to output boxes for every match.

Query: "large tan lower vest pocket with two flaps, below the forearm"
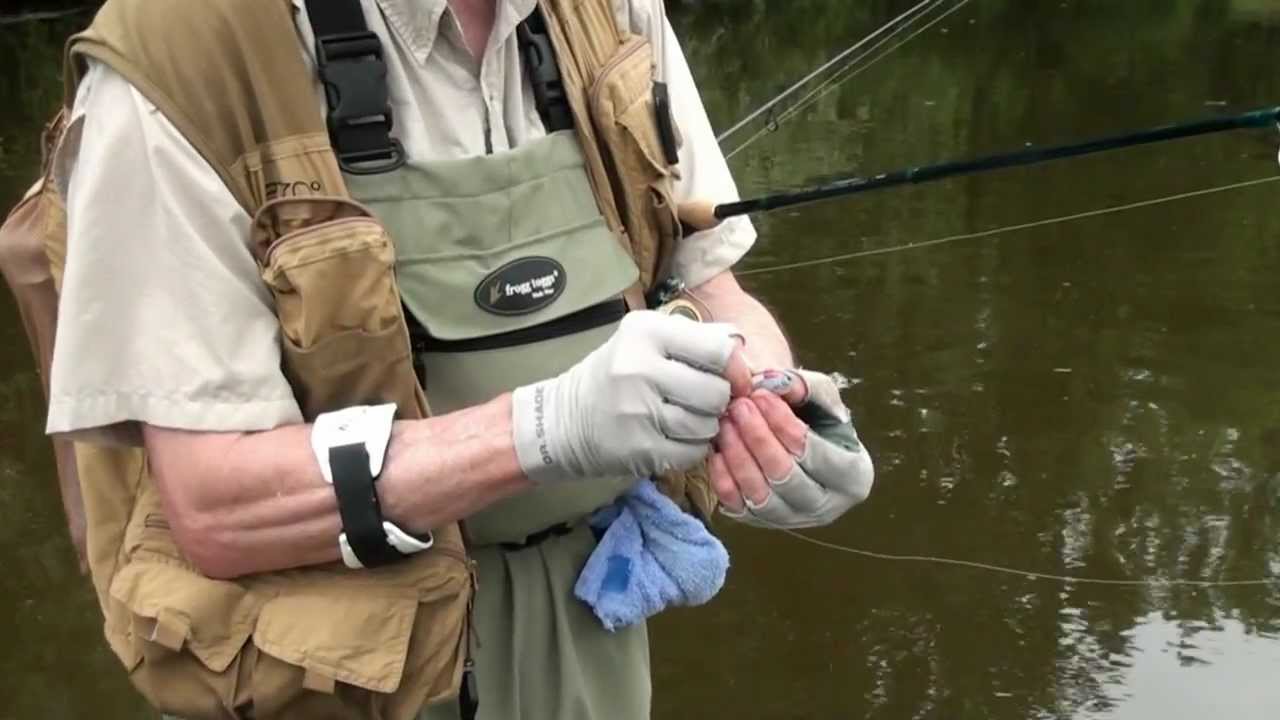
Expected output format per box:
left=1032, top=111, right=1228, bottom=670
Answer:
left=106, top=499, right=472, bottom=720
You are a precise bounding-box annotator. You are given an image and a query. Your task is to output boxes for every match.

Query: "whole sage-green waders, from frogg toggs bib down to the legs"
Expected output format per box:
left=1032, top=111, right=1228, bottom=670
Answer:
left=347, top=131, right=650, bottom=720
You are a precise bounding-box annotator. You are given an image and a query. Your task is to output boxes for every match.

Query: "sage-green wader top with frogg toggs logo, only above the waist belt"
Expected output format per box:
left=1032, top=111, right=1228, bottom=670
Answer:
left=347, top=131, right=637, bottom=544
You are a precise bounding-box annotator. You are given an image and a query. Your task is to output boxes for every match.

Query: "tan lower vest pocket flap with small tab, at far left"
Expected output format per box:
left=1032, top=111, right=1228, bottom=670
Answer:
left=110, top=560, right=261, bottom=673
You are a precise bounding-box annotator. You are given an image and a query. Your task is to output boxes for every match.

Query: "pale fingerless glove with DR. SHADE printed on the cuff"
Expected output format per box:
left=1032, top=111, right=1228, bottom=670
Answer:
left=512, top=311, right=736, bottom=482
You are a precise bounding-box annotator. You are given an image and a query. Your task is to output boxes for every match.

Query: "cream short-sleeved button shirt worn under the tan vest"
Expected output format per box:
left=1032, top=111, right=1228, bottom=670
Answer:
left=46, top=0, right=755, bottom=445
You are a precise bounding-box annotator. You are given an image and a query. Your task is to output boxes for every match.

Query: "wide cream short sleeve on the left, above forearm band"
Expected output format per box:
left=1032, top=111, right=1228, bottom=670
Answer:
left=46, top=63, right=301, bottom=445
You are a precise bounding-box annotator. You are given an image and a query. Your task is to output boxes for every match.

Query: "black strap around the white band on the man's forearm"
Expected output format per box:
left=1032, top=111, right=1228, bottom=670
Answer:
left=329, top=443, right=404, bottom=568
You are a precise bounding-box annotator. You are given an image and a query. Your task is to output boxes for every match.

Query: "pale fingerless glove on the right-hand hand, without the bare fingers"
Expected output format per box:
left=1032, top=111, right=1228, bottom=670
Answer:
left=721, top=370, right=876, bottom=529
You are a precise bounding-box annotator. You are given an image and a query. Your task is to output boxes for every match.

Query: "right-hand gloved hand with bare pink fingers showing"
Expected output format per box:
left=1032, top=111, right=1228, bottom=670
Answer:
left=709, top=372, right=874, bottom=528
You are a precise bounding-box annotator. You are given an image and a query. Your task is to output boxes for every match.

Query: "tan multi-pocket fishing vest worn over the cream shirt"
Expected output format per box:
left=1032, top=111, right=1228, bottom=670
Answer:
left=0, top=0, right=714, bottom=720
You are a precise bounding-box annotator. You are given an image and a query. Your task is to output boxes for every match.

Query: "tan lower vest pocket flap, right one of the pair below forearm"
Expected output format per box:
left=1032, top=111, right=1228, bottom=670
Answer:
left=253, top=584, right=419, bottom=693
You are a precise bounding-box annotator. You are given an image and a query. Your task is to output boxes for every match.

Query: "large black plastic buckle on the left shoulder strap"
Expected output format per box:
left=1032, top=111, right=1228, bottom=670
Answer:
left=316, top=31, right=406, bottom=176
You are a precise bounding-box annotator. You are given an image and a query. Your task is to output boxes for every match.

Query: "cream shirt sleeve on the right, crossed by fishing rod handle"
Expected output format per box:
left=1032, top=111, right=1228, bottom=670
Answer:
left=616, top=0, right=756, bottom=287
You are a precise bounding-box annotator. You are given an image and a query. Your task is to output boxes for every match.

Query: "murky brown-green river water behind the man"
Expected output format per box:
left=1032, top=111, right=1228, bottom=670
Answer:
left=0, top=0, right=1280, bottom=720
